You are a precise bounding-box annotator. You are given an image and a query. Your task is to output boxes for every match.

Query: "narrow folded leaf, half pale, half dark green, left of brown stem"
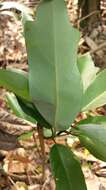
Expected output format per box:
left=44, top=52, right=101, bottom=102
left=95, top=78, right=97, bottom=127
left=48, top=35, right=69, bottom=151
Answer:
left=6, top=93, right=51, bottom=128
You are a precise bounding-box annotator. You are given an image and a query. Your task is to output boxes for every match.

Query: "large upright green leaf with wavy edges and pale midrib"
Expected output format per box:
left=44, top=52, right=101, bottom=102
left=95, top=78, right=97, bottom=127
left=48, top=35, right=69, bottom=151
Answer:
left=25, top=0, right=83, bottom=130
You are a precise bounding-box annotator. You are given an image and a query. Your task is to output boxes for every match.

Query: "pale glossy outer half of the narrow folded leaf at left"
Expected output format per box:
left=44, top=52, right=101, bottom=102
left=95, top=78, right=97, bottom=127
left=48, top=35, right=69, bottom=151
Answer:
left=6, top=93, right=36, bottom=123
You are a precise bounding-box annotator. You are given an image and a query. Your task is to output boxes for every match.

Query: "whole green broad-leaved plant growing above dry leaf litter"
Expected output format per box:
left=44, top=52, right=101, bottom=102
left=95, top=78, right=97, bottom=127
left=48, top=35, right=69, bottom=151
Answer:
left=0, top=0, right=106, bottom=190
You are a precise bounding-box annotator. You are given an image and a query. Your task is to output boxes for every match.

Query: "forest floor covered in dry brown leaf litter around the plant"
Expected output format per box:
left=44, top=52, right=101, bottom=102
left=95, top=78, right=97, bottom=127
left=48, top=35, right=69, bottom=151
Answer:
left=0, top=0, right=106, bottom=190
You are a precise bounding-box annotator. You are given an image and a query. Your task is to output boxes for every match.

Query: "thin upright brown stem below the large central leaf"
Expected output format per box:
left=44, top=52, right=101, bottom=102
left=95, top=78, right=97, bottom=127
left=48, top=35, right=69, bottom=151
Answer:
left=37, top=124, right=46, bottom=182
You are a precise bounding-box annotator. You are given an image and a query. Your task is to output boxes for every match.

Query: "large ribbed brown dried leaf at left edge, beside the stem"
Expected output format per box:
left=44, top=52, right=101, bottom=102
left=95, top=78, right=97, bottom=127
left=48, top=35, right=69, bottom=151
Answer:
left=0, top=108, right=35, bottom=151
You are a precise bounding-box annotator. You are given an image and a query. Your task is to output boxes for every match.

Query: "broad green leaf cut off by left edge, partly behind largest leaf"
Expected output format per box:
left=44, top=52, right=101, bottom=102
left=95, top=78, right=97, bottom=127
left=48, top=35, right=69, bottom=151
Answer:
left=0, top=69, right=31, bottom=101
